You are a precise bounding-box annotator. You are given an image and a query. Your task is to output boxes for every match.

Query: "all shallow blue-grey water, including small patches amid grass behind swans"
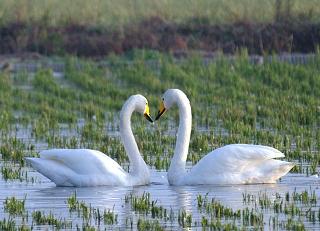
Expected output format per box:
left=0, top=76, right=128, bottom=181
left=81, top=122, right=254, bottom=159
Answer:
left=0, top=122, right=320, bottom=230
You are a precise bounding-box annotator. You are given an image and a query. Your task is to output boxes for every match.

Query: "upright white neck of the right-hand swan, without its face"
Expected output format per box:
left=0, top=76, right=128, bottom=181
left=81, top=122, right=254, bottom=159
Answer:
left=168, top=94, right=192, bottom=184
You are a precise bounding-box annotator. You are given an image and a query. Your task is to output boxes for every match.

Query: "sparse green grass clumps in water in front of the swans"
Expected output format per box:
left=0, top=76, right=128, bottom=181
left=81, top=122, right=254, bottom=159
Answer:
left=0, top=191, right=320, bottom=230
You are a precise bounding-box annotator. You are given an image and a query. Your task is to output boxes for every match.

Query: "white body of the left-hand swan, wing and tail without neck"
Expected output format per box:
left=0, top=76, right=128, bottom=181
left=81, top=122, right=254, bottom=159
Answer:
left=26, top=149, right=128, bottom=186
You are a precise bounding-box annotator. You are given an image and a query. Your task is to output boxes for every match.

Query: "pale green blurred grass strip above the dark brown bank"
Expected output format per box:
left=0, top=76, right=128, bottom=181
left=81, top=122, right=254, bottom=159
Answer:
left=0, top=0, right=320, bottom=27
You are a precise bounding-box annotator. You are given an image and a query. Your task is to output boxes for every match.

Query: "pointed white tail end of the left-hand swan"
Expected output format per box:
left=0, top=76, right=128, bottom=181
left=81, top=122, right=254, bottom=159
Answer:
left=26, top=158, right=74, bottom=186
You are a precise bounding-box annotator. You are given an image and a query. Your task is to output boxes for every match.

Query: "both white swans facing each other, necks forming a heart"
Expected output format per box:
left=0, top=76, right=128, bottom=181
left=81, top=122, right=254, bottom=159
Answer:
left=27, top=89, right=294, bottom=186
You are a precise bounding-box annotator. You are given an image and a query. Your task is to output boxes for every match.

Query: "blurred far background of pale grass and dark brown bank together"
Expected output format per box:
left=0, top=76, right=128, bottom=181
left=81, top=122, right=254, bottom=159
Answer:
left=0, top=0, right=320, bottom=57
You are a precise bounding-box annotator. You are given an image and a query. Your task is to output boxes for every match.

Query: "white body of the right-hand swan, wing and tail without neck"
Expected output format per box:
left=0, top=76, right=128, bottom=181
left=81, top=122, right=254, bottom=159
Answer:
left=184, top=144, right=294, bottom=184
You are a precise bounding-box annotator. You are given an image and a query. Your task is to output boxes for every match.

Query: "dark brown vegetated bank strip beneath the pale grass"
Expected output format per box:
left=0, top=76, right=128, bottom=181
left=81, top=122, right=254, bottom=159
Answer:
left=0, top=17, right=320, bottom=58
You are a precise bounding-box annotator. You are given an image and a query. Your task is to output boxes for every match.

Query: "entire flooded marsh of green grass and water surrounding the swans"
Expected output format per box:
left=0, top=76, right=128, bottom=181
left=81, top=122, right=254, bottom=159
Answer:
left=0, top=51, right=320, bottom=230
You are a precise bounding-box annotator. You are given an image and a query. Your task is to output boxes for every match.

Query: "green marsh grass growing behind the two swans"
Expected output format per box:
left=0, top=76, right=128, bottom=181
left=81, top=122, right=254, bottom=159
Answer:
left=0, top=51, right=320, bottom=174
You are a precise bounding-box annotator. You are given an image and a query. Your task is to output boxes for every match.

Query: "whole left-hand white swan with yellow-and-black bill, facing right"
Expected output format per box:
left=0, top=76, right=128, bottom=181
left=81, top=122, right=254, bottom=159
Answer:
left=26, top=95, right=153, bottom=187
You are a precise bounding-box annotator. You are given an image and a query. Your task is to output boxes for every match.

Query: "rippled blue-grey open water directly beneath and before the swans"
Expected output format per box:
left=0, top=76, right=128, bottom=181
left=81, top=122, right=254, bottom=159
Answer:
left=0, top=163, right=320, bottom=230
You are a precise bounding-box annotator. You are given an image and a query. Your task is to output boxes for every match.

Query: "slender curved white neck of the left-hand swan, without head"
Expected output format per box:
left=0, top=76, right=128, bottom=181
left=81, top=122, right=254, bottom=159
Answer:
left=120, top=102, right=149, bottom=176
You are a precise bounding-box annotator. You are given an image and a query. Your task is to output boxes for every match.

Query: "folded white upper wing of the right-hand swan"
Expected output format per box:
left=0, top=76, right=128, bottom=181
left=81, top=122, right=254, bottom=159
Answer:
left=190, top=144, right=284, bottom=175
